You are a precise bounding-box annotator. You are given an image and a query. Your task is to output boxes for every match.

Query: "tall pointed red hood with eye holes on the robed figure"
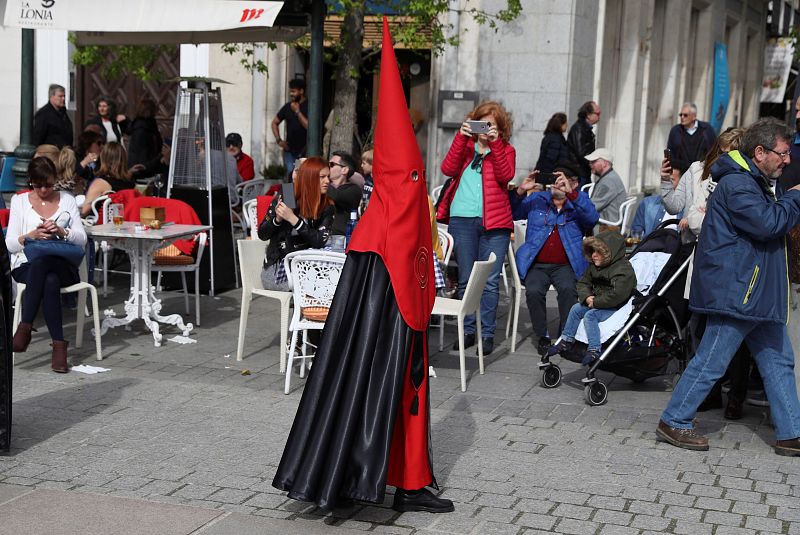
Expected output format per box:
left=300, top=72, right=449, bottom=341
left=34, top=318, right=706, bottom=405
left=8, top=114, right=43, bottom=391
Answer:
left=348, top=17, right=436, bottom=331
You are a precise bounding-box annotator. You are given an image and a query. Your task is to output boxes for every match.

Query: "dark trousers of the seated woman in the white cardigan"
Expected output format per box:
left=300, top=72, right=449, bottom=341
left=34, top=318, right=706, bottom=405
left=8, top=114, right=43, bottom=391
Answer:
left=11, top=256, right=80, bottom=340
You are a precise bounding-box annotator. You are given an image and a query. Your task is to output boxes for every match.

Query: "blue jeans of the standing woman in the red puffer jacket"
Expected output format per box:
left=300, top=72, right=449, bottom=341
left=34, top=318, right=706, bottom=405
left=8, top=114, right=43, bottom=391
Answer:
left=447, top=217, right=511, bottom=338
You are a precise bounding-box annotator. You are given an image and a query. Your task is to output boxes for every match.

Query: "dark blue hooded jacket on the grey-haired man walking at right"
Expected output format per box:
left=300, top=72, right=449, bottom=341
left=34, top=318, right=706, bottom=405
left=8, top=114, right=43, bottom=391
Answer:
left=689, top=151, right=800, bottom=323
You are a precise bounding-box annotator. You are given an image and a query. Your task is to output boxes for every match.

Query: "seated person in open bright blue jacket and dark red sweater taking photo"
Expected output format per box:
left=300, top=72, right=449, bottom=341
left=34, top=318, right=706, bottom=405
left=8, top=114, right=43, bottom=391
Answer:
left=510, top=162, right=600, bottom=355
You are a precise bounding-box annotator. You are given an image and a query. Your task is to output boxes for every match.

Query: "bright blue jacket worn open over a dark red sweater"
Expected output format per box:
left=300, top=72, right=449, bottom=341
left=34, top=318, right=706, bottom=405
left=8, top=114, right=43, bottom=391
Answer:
left=509, top=191, right=600, bottom=279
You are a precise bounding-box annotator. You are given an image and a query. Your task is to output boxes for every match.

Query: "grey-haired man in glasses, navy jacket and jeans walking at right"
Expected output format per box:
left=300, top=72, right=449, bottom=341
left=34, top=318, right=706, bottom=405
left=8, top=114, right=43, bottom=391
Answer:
left=656, top=119, right=800, bottom=456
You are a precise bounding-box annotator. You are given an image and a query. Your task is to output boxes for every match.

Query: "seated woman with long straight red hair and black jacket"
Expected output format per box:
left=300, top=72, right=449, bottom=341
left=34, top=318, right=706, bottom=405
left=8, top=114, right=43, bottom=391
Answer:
left=258, top=158, right=334, bottom=291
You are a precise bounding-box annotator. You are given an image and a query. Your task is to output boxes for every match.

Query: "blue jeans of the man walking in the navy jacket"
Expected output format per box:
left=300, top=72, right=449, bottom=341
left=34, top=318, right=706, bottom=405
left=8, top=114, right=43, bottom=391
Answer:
left=661, top=315, right=800, bottom=440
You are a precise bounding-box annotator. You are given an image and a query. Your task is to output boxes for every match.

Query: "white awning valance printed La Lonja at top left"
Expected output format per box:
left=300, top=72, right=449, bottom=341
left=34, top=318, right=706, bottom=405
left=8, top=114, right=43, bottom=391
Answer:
left=0, top=0, right=284, bottom=32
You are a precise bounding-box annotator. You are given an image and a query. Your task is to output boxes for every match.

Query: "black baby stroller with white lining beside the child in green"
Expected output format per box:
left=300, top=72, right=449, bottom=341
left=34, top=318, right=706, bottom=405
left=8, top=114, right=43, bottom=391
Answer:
left=539, top=219, right=695, bottom=406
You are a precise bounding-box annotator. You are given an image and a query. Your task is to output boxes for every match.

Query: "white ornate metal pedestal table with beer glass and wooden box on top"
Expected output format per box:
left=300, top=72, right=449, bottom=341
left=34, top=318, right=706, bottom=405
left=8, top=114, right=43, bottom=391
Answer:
left=86, top=222, right=211, bottom=347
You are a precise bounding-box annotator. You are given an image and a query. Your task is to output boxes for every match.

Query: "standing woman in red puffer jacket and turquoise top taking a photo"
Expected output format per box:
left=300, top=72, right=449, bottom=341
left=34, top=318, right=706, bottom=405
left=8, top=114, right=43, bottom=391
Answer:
left=436, top=101, right=517, bottom=354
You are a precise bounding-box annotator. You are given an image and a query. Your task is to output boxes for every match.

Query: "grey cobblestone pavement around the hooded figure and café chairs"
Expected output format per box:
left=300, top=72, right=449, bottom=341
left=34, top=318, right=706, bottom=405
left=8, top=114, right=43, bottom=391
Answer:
left=0, top=279, right=800, bottom=535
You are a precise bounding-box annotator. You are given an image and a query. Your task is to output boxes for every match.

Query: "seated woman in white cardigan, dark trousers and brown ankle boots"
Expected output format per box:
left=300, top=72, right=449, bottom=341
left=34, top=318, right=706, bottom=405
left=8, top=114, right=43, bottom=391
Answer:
left=6, top=157, right=86, bottom=373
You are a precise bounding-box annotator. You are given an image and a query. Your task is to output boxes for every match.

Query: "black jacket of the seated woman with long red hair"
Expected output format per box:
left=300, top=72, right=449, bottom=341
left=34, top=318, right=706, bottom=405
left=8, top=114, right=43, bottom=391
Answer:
left=258, top=196, right=334, bottom=267
